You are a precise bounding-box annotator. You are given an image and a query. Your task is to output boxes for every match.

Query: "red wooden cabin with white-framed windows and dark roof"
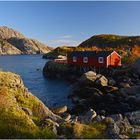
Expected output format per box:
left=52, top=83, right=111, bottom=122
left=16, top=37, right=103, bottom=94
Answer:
left=67, top=51, right=121, bottom=68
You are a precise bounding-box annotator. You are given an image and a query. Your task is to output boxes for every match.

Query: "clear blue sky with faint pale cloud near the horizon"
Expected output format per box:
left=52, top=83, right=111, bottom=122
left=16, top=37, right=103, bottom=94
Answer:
left=0, top=1, right=140, bottom=47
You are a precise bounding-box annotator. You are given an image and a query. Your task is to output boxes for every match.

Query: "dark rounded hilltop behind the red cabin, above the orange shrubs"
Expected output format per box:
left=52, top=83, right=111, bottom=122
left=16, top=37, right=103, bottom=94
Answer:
left=79, top=34, right=140, bottom=48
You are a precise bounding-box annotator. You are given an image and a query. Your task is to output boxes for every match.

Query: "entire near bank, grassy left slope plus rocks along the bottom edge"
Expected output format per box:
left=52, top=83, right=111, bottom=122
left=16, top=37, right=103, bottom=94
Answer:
left=0, top=72, right=140, bottom=139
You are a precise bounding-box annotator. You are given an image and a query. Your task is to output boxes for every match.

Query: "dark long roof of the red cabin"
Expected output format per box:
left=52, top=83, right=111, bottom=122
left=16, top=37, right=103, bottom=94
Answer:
left=68, top=51, right=112, bottom=57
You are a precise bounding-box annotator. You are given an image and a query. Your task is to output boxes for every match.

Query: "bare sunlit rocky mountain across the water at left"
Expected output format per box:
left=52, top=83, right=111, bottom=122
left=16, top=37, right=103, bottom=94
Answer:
left=0, top=26, right=50, bottom=55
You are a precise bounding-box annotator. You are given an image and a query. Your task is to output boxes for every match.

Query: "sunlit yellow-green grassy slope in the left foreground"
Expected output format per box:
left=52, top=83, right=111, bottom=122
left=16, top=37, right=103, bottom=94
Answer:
left=0, top=72, right=55, bottom=138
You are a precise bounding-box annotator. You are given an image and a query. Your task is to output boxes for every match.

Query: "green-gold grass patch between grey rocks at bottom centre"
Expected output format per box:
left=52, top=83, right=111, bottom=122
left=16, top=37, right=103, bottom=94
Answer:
left=59, top=122, right=107, bottom=139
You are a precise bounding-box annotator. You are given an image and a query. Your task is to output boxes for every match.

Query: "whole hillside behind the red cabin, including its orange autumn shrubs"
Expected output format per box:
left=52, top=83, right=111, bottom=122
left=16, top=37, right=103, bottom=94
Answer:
left=78, top=34, right=140, bottom=62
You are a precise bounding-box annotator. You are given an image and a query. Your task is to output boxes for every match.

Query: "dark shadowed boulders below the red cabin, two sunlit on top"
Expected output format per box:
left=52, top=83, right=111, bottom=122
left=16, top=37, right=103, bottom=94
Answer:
left=70, top=67, right=140, bottom=115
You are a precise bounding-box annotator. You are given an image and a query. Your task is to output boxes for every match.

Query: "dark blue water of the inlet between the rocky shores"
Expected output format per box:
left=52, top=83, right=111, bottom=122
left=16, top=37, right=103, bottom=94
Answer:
left=0, top=55, right=71, bottom=107
